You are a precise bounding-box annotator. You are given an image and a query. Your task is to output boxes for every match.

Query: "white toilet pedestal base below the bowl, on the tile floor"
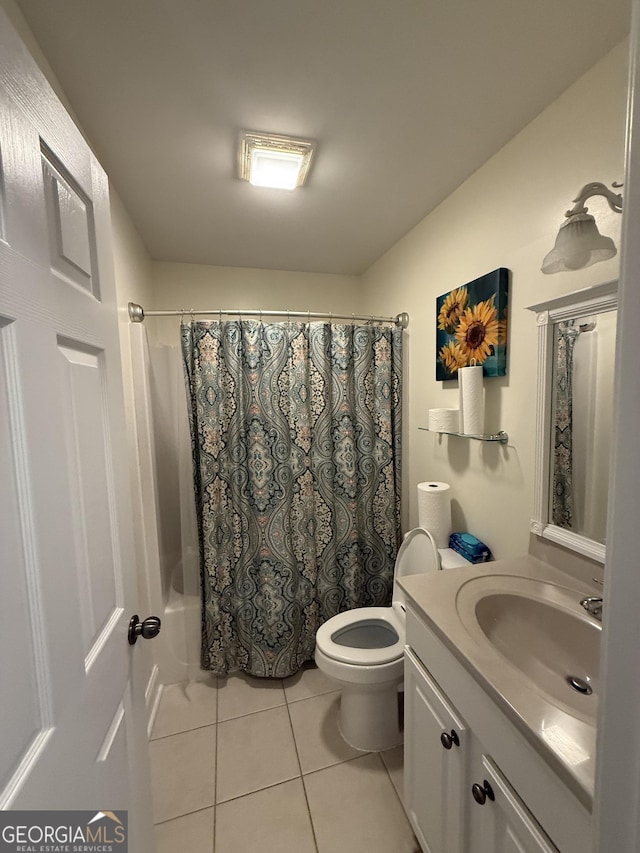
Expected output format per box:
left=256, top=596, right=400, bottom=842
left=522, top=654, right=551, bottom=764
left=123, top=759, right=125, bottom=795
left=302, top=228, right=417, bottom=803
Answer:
left=338, top=681, right=403, bottom=752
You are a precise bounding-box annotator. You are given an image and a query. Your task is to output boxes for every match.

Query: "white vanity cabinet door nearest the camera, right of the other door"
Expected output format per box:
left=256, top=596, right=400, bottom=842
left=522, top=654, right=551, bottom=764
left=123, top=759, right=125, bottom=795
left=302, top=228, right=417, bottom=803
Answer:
left=466, top=755, right=558, bottom=853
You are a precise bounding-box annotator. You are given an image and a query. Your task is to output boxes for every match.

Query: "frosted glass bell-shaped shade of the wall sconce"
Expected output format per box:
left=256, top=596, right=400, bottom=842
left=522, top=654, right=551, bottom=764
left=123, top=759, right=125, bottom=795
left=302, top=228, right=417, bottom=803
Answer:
left=541, top=213, right=617, bottom=275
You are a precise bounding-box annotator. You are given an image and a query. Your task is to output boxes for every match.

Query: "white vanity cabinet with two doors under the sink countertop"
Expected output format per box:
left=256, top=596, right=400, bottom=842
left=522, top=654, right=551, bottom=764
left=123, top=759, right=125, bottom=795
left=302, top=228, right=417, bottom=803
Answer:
left=404, top=608, right=591, bottom=853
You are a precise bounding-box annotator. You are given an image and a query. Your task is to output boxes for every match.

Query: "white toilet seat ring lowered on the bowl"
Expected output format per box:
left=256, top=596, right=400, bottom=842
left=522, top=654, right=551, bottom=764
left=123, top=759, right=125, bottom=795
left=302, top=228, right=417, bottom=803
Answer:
left=316, top=607, right=405, bottom=666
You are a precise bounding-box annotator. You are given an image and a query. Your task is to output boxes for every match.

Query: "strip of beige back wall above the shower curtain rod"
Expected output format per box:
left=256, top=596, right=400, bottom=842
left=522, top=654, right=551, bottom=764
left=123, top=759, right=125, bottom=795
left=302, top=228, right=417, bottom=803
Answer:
left=143, top=262, right=362, bottom=345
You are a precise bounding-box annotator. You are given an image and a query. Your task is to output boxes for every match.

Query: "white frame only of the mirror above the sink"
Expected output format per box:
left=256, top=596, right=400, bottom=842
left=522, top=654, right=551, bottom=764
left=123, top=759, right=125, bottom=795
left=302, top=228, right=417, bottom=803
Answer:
left=528, top=279, right=618, bottom=563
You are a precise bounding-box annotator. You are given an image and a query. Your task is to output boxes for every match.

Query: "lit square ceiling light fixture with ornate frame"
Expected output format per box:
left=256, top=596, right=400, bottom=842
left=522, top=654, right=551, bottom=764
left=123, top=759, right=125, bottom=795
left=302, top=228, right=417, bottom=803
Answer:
left=238, top=131, right=316, bottom=190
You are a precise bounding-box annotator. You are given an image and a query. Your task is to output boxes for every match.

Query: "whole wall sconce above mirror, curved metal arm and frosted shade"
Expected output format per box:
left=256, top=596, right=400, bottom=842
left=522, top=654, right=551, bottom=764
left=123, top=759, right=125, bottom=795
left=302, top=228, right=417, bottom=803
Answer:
left=541, top=182, right=622, bottom=275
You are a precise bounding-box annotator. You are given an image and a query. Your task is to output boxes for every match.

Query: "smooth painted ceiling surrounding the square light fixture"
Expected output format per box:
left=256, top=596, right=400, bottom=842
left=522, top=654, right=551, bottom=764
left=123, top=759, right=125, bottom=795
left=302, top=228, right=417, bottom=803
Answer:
left=17, top=0, right=630, bottom=274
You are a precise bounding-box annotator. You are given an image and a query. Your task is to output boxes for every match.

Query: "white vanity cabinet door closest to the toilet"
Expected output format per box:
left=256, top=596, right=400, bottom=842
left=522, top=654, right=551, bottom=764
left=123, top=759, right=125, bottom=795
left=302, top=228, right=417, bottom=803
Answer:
left=404, top=649, right=469, bottom=853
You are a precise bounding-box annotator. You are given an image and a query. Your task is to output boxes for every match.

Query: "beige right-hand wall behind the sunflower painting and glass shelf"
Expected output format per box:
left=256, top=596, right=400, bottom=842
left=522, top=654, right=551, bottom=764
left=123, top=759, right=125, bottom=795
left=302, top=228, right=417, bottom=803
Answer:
left=364, top=43, right=627, bottom=558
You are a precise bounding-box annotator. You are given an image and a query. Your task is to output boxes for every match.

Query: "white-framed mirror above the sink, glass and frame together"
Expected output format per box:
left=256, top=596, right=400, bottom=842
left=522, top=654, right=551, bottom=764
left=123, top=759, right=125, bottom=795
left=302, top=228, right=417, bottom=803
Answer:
left=530, top=281, right=617, bottom=562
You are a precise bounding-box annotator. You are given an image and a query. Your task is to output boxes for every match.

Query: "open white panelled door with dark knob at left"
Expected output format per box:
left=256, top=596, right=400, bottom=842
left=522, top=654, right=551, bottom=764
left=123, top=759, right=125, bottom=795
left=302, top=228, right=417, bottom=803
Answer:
left=0, top=10, right=152, bottom=853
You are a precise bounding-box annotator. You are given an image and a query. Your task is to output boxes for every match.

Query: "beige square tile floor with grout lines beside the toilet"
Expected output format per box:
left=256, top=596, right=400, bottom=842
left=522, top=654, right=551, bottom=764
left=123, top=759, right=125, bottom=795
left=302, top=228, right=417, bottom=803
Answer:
left=150, top=665, right=419, bottom=853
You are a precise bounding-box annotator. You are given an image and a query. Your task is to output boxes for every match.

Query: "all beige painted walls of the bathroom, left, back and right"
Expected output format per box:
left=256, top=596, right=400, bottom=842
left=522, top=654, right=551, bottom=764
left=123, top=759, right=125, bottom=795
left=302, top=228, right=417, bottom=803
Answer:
left=11, top=0, right=627, bottom=557
